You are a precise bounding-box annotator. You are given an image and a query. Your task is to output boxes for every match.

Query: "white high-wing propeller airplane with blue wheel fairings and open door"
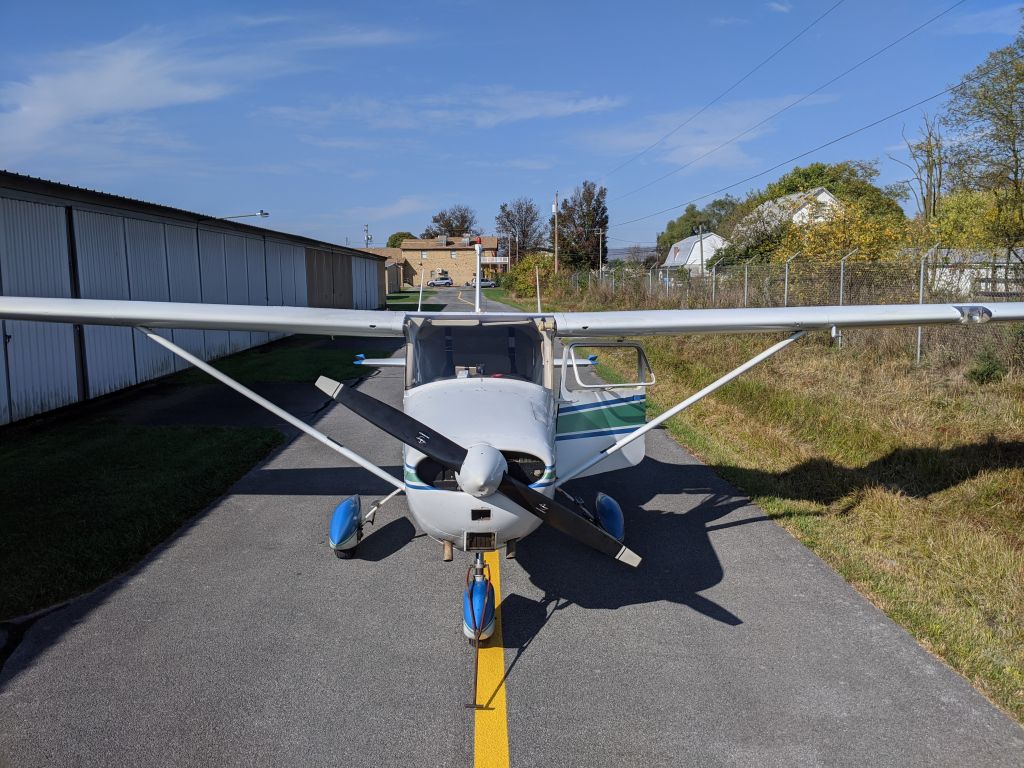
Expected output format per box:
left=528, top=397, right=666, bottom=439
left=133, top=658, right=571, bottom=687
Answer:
left=0, top=249, right=1024, bottom=644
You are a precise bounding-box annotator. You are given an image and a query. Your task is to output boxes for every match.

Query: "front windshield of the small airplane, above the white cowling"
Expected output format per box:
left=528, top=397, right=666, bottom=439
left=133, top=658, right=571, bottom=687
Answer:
left=412, top=324, right=544, bottom=386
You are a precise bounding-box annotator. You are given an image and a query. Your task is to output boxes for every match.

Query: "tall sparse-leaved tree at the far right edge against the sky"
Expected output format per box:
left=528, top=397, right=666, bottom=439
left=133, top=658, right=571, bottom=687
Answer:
left=942, top=12, right=1024, bottom=257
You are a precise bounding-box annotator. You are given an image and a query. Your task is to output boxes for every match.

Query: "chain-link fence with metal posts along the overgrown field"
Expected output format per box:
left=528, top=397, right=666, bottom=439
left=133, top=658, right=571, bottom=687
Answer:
left=568, top=249, right=1024, bottom=368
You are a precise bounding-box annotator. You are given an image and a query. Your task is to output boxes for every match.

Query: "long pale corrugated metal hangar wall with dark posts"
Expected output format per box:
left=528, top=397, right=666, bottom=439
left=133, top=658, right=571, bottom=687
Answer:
left=0, top=174, right=384, bottom=424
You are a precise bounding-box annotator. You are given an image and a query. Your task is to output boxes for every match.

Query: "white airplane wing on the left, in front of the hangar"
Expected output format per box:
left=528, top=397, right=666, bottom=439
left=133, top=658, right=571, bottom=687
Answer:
left=0, top=296, right=406, bottom=336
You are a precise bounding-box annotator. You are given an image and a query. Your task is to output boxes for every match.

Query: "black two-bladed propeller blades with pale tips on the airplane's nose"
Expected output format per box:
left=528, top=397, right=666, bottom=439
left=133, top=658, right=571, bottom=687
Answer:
left=316, top=376, right=640, bottom=567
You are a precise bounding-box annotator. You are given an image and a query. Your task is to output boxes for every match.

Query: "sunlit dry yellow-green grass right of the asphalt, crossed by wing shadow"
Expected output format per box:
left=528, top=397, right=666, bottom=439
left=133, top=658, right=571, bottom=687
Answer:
left=599, top=336, right=1024, bottom=721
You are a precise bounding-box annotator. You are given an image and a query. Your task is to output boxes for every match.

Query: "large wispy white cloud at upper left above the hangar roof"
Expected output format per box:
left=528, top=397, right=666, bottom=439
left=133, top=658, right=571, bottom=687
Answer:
left=0, top=22, right=408, bottom=167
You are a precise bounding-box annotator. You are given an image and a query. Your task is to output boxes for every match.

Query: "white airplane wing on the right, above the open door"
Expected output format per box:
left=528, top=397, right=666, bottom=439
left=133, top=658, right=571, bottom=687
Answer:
left=553, top=301, right=1024, bottom=337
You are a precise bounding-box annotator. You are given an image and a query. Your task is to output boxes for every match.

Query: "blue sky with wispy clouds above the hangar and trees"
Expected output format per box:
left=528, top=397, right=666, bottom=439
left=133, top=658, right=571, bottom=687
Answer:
left=0, top=0, right=1020, bottom=246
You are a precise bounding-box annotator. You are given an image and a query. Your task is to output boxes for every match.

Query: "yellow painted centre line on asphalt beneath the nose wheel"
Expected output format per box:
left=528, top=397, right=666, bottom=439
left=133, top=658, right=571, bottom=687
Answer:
left=473, top=551, right=509, bottom=768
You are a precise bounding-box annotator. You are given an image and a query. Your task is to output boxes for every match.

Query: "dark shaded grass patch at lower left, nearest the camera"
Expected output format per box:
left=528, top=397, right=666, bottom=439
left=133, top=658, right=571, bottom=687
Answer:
left=0, top=421, right=285, bottom=618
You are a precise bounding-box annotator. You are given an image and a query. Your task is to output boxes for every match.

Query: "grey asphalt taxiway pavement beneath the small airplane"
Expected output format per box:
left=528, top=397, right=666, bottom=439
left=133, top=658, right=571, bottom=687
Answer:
left=0, top=292, right=1024, bottom=768
